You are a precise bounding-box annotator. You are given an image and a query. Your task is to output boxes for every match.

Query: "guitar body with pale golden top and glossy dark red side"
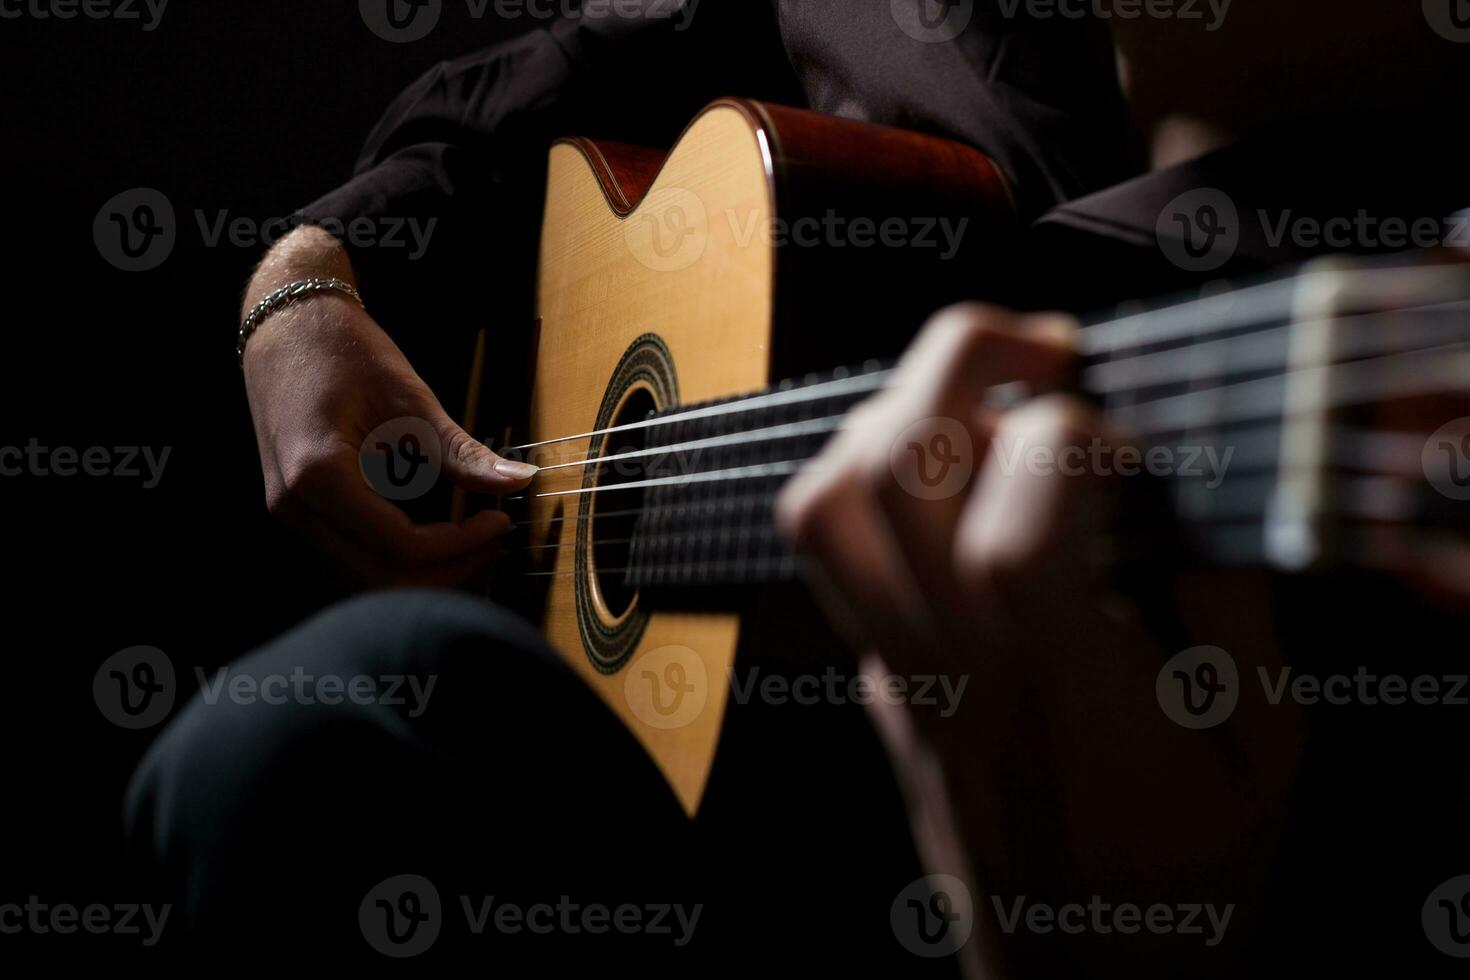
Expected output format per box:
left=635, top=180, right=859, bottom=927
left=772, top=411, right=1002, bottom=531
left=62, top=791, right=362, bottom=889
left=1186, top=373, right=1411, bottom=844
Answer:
left=507, top=100, right=1011, bottom=814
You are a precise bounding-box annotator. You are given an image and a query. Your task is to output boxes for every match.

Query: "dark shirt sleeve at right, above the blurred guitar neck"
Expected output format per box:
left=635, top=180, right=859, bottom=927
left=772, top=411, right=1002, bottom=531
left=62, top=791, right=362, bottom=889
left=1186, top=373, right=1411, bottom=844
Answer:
left=1026, top=113, right=1470, bottom=314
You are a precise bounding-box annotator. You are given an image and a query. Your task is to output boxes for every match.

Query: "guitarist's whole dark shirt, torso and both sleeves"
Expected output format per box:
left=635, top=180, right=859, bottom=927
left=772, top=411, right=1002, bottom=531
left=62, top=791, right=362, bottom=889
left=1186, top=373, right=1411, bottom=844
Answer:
left=306, top=0, right=1470, bottom=390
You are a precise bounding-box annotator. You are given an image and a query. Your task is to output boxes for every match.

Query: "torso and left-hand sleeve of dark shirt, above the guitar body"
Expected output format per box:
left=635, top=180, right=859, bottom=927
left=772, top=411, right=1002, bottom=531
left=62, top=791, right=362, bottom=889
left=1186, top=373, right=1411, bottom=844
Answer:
left=307, top=0, right=1129, bottom=373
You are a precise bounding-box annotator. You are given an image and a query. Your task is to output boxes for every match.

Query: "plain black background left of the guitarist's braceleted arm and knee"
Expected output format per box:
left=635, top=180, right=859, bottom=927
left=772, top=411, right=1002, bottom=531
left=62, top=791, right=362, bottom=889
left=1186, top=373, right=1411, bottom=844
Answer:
left=0, top=0, right=532, bottom=961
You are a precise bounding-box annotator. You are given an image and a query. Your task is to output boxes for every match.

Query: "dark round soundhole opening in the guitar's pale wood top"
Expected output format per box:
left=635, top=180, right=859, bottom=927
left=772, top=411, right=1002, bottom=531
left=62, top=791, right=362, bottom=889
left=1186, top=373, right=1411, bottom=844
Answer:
left=592, top=385, right=657, bottom=621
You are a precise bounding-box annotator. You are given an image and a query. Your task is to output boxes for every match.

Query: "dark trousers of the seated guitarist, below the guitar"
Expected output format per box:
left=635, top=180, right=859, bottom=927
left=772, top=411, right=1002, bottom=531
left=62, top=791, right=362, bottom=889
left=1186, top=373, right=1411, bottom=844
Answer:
left=126, top=591, right=947, bottom=976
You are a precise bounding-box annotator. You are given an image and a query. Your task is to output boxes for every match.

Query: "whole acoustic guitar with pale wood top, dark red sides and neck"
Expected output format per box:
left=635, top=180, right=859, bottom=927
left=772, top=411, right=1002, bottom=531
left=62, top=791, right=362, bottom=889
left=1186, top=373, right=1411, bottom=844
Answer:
left=469, top=100, right=1470, bottom=815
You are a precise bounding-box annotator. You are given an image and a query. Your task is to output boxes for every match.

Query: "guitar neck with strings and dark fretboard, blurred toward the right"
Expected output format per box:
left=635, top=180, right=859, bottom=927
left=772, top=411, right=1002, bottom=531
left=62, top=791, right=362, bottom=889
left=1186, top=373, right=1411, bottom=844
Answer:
left=598, top=258, right=1470, bottom=589
